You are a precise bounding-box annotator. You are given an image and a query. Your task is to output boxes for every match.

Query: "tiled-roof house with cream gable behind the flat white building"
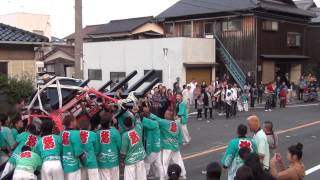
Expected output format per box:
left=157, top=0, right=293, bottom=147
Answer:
left=65, top=16, right=163, bottom=44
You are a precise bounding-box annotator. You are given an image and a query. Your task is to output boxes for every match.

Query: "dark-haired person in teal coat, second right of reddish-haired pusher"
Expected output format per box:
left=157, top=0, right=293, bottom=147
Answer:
left=97, top=113, right=121, bottom=180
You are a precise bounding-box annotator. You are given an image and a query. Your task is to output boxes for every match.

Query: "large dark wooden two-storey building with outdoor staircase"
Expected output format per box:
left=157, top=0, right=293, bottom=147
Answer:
left=156, top=0, right=315, bottom=86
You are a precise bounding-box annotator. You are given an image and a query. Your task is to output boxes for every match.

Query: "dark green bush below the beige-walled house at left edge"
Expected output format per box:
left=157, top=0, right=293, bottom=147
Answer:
left=0, top=76, right=34, bottom=105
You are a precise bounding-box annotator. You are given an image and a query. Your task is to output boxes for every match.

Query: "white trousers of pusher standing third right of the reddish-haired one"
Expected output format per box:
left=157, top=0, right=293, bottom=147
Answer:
left=124, top=161, right=147, bottom=180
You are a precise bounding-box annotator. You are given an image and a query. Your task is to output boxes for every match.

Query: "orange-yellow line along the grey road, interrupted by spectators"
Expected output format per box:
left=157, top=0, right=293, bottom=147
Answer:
left=182, top=121, right=320, bottom=160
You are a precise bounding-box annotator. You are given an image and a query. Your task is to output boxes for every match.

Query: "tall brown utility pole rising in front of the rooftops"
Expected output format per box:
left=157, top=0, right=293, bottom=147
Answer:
left=74, top=0, right=83, bottom=79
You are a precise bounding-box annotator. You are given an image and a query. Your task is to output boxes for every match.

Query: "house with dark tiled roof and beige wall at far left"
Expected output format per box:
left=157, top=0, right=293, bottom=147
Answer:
left=0, top=23, right=49, bottom=78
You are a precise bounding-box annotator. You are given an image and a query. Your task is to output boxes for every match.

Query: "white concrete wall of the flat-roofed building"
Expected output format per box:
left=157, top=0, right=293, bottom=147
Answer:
left=83, top=37, right=215, bottom=87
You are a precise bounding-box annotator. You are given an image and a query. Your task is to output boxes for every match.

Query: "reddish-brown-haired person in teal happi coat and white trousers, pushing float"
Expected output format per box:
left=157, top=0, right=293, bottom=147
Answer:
left=61, top=115, right=83, bottom=180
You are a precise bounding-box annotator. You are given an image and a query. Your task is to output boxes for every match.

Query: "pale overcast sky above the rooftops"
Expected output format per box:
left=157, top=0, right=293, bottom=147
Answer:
left=0, top=0, right=320, bottom=38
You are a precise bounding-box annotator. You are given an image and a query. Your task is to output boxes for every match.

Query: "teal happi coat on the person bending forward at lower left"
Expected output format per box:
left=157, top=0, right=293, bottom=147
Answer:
left=16, top=151, right=42, bottom=172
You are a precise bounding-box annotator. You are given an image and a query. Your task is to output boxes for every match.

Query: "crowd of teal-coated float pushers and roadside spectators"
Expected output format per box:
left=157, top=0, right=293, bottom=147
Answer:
left=0, top=74, right=312, bottom=180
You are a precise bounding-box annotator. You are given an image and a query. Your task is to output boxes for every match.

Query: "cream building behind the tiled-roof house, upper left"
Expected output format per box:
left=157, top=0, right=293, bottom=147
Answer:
left=0, top=12, right=51, bottom=39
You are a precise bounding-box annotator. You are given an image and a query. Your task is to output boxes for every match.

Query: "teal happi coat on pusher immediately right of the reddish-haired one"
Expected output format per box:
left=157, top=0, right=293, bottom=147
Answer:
left=80, top=130, right=98, bottom=169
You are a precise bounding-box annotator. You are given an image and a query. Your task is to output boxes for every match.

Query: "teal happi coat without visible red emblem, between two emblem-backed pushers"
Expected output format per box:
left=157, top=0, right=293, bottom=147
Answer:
left=142, top=118, right=161, bottom=155
